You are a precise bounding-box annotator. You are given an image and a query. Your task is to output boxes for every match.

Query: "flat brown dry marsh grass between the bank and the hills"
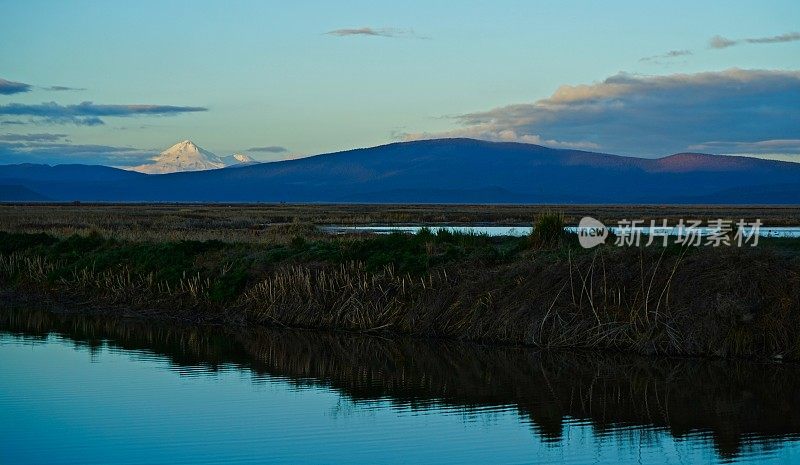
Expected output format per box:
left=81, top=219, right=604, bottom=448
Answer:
left=0, top=204, right=800, bottom=243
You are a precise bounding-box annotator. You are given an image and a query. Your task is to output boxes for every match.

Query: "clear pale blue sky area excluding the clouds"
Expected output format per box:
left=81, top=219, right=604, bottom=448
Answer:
left=0, top=0, right=800, bottom=163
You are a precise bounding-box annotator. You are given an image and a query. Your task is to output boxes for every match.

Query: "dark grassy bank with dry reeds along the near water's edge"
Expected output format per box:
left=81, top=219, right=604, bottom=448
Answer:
left=0, top=228, right=800, bottom=359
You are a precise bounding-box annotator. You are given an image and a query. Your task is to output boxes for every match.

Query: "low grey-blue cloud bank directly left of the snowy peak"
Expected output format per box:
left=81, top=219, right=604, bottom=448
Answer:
left=0, top=141, right=155, bottom=167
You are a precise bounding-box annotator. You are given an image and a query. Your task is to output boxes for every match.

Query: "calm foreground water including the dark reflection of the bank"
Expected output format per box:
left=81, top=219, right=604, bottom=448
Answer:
left=0, top=310, right=800, bottom=464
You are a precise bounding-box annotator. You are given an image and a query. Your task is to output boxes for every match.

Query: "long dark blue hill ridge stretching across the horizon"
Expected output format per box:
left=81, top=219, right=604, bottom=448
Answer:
left=0, top=139, right=800, bottom=204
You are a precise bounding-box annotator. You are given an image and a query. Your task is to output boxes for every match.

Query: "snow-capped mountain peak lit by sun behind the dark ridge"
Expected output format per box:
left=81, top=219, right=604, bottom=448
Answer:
left=131, top=140, right=253, bottom=174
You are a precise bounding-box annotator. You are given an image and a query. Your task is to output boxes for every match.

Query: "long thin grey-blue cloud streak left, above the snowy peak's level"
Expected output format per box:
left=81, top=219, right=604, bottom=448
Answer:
left=0, top=102, right=208, bottom=126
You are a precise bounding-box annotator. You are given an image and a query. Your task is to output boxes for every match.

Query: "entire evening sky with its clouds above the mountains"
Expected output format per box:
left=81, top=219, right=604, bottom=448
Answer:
left=0, top=0, right=800, bottom=166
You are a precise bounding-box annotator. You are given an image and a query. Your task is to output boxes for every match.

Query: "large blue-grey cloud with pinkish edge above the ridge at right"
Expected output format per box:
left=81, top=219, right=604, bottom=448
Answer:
left=404, top=69, right=800, bottom=156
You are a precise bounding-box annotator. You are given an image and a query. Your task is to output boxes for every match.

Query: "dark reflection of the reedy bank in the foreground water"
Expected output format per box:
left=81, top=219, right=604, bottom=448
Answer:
left=0, top=310, right=800, bottom=460
